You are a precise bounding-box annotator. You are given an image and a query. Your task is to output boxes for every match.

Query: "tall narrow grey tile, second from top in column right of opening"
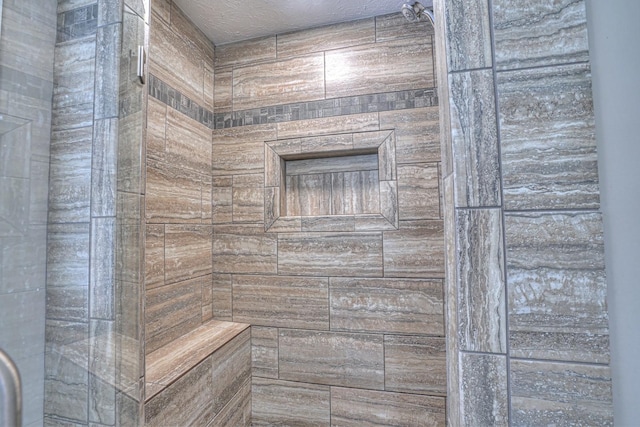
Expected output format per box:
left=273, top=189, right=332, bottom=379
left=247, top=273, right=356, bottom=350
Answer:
left=449, top=70, right=501, bottom=207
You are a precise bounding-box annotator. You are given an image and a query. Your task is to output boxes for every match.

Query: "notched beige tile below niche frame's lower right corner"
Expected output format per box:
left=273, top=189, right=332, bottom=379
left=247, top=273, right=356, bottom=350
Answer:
left=384, top=221, right=444, bottom=278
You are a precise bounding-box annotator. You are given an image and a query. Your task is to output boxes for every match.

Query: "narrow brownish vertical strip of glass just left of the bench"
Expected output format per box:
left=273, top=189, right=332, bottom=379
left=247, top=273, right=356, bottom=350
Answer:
left=115, top=1, right=149, bottom=425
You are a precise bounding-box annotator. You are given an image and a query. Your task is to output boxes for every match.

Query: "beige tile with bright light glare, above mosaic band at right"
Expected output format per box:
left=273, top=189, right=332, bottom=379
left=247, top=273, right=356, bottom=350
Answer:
left=325, top=38, right=435, bottom=98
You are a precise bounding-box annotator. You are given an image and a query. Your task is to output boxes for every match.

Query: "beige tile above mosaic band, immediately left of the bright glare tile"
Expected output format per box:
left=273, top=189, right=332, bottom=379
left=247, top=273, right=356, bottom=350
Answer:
left=233, top=53, right=324, bottom=110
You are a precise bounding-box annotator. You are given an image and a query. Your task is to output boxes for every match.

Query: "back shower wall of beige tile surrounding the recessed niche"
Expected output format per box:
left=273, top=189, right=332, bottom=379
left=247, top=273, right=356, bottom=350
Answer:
left=212, top=14, right=446, bottom=425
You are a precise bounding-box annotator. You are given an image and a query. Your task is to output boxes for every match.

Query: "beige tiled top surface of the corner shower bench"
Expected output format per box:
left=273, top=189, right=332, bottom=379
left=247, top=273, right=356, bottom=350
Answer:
left=145, top=320, right=250, bottom=402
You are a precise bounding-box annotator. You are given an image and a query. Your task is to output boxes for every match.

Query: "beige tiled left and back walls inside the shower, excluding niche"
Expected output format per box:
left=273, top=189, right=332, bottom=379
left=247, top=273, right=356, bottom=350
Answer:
left=145, top=1, right=446, bottom=425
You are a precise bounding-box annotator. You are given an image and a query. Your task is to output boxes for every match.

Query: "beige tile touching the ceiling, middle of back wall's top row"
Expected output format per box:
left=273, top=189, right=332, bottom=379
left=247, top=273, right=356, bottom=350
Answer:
left=277, top=18, right=375, bottom=58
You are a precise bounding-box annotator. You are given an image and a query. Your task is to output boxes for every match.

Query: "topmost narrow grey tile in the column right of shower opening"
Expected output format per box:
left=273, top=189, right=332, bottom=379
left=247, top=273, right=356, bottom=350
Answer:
left=444, top=0, right=492, bottom=71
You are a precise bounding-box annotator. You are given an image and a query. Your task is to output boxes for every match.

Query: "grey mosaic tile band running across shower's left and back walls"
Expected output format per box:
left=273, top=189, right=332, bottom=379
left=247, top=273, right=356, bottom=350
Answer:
left=148, top=74, right=438, bottom=129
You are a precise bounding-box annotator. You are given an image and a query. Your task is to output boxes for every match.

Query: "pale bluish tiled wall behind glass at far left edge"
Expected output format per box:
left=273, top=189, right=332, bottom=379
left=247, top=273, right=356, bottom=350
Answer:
left=0, top=0, right=56, bottom=426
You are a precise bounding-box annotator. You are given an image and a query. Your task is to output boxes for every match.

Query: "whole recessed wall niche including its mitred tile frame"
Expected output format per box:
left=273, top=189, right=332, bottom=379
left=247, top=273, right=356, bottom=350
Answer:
left=264, top=130, right=398, bottom=232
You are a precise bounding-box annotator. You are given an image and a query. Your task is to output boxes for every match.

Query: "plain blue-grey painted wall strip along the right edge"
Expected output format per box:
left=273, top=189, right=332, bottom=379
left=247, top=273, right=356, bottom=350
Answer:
left=587, top=0, right=640, bottom=426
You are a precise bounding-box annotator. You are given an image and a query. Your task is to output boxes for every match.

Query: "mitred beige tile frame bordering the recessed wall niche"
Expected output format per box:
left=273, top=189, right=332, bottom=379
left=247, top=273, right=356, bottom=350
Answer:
left=264, top=130, right=399, bottom=233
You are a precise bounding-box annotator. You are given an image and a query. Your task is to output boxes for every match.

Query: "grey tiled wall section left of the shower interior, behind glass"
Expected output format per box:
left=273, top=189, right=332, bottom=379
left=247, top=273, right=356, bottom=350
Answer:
left=44, top=0, right=148, bottom=426
